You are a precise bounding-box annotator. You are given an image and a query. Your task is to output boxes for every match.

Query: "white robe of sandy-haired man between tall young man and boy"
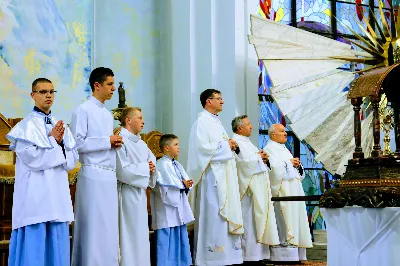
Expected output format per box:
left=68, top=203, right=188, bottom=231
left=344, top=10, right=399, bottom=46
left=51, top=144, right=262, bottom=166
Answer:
left=117, top=128, right=157, bottom=266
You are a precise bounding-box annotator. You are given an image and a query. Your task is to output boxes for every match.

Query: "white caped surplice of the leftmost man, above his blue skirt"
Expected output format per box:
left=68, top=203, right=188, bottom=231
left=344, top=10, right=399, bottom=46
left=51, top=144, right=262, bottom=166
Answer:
left=7, top=111, right=78, bottom=230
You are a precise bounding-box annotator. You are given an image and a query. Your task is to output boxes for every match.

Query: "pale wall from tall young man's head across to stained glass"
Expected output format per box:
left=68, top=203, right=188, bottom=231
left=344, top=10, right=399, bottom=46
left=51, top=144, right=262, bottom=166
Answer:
left=94, top=0, right=258, bottom=165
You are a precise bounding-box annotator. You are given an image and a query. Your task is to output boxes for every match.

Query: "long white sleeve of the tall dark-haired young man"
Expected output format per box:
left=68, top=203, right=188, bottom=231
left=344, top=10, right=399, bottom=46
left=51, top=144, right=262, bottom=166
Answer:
left=70, top=108, right=111, bottom=153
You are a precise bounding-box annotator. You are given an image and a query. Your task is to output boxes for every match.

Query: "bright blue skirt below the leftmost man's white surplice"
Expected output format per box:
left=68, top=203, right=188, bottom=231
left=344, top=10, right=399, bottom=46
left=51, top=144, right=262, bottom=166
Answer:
left=8, top=222, right=71, bottom=266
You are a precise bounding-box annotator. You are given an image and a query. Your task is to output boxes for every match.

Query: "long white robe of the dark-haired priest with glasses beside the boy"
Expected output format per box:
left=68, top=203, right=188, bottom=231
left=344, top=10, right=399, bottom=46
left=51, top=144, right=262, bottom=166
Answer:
left=187, top=110, right=244, bottom=265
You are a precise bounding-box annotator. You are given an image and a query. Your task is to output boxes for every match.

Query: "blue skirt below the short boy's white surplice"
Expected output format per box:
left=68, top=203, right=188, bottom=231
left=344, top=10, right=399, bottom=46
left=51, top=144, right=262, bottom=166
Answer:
left=154, top=225, right=192, bottom=266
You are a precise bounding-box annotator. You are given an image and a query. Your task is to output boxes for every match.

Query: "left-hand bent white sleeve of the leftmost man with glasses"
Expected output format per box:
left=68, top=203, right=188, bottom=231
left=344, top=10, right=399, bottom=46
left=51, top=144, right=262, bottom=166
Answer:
left=15, top=136, right=67, bottom=171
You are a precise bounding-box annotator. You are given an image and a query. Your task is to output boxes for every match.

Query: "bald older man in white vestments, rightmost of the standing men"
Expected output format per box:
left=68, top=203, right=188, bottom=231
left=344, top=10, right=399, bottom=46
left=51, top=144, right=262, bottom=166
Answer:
left=264, top=124, right=312, bottom=261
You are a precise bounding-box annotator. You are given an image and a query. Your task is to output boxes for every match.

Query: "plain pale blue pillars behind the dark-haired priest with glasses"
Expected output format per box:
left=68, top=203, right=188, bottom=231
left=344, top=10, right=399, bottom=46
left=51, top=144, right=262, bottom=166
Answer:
left=156, top=0, right=258, bottom=165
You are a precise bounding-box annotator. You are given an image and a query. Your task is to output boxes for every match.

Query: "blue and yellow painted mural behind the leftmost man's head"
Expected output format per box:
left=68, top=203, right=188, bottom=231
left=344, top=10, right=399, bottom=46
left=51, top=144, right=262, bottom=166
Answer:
left=0, top=0, right=93, bottom=122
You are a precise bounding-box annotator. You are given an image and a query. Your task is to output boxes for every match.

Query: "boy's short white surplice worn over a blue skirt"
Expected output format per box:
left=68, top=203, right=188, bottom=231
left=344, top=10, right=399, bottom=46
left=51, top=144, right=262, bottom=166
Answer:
left=151, top=156, right=194, bottom=230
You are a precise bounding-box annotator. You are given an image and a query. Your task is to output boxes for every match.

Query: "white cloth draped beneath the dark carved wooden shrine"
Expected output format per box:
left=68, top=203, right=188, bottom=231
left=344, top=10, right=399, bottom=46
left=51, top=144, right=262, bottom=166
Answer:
left=321, top=207, right=400, bottom=266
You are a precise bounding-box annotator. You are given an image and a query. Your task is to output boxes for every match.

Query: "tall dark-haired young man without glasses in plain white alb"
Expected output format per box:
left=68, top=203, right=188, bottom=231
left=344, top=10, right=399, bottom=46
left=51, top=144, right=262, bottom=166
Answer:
left=71, top=67, right=122, bottom=266
